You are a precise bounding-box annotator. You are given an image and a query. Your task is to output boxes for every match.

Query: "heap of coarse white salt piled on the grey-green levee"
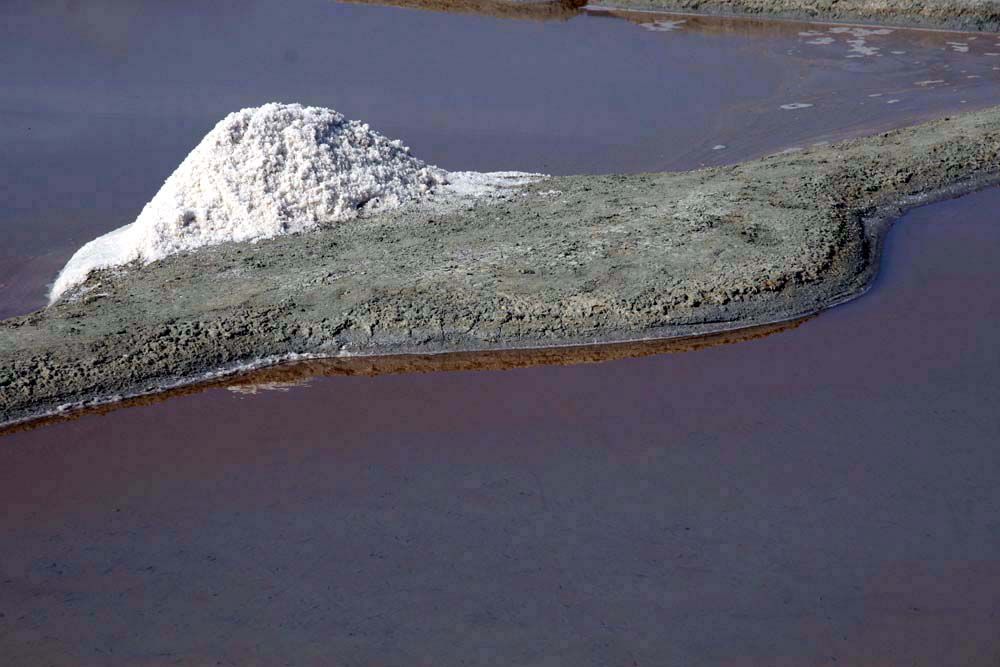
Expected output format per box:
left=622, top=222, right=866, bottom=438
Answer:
left=49, top=104, right=541, bottom=302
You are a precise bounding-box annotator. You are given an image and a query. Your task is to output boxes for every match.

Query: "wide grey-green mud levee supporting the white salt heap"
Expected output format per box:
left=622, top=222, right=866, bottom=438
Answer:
left=0, top=107, right=1000, bottom=423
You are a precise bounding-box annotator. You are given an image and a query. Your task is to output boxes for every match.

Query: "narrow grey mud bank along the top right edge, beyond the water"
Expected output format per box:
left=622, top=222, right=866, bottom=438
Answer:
left=594, top=0, right=1000, bottom=32
